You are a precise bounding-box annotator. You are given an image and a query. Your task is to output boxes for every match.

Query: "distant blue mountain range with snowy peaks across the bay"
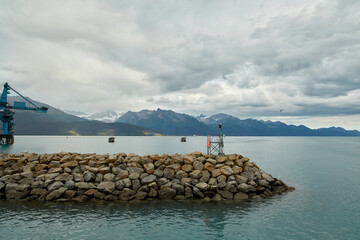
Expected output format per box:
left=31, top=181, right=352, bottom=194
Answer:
left=3, top=97, right=360, bottom=136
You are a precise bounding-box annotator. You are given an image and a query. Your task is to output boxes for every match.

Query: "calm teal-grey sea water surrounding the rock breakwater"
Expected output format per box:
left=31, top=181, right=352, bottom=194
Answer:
left=0, top=137, right=360, bottom=240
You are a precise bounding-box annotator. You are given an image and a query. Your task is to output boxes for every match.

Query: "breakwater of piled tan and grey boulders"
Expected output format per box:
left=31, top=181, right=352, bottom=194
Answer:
left=0, top=152, right=294, bottom=201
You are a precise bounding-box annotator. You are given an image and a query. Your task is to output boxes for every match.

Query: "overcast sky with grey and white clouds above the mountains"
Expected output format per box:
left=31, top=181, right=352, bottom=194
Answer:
left=0, top=0, right=360, bottom=130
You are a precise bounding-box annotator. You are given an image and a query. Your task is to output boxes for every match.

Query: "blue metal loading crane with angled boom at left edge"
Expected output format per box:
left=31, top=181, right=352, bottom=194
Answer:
left=0, top=83, right=48, bottom=144
